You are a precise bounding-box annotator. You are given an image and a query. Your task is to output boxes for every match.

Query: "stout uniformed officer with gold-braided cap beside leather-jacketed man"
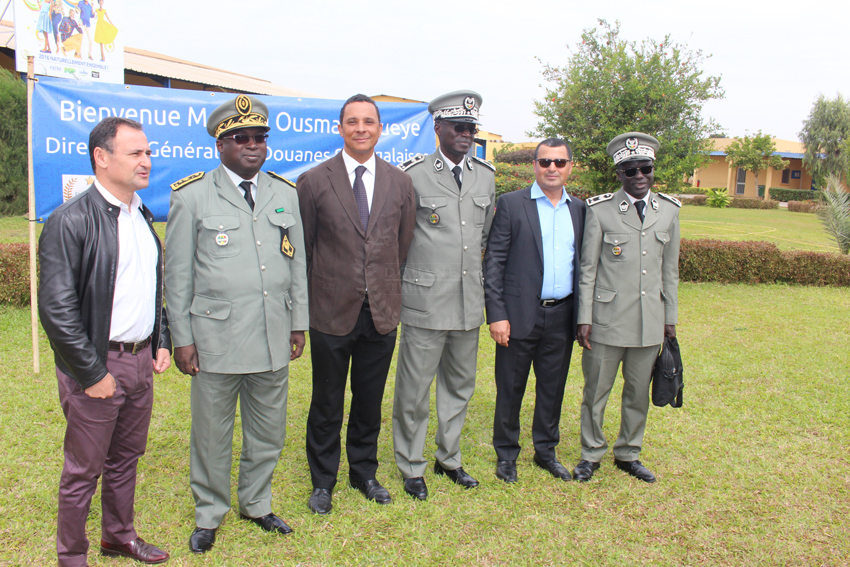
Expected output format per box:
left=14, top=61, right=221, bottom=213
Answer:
left=165, top=95, right=309, bottom=553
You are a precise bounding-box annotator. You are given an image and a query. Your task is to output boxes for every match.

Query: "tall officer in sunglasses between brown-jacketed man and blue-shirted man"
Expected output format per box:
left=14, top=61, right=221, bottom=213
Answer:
left=393, top=87, right=496, bottom=500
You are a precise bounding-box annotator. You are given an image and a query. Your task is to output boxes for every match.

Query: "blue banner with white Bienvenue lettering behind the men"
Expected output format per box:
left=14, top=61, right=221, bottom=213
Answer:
left=33, top=77, right=436, bottom=221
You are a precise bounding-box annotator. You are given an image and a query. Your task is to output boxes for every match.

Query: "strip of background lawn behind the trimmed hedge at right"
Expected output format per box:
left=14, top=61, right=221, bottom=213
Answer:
left=679, top=205, right=839, bottom=252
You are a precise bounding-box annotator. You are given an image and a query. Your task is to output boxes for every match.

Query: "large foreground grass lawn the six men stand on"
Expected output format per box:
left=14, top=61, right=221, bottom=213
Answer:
left=0, top=284, right=850, bottom=567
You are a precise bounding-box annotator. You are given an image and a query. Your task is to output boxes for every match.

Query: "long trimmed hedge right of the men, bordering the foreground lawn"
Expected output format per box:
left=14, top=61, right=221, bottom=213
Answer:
left=679, top=239, right=850, bottom=286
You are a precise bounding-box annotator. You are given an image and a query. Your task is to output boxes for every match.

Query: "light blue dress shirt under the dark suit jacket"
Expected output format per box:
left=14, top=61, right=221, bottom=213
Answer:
left=531, top=181, right=576, bottom=299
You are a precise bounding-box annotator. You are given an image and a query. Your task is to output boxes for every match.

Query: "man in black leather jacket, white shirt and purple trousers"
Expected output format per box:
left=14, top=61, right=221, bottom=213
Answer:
left=39, top=117, right=171, bottom=566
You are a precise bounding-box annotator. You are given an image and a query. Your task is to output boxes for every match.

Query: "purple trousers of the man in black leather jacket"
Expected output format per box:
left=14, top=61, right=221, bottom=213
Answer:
left=56, top=346, right=153, bottom=567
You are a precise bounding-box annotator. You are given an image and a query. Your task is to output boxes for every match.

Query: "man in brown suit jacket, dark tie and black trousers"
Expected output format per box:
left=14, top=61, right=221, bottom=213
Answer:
left=296, top=95, right=416, bottom=514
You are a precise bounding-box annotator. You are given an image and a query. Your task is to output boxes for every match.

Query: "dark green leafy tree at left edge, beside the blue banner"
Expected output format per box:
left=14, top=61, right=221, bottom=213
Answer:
left=0, top=69, right=27, bottom=216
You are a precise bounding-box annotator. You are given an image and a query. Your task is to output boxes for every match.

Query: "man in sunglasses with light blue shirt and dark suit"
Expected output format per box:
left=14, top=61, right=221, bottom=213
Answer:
left=484, top=138, right=585, bottom=483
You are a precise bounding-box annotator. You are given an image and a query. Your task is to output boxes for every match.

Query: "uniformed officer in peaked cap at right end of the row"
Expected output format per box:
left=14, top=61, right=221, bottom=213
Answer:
left=574, top=132, right=681, bottom=482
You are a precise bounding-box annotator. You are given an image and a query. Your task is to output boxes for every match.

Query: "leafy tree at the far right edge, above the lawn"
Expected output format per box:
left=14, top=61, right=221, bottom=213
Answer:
left=799, top=94, right=850, bottom=187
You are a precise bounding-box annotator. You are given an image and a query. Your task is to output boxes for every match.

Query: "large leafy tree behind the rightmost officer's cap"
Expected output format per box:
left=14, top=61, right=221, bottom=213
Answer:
left=529, top=20, right=724, bottom=193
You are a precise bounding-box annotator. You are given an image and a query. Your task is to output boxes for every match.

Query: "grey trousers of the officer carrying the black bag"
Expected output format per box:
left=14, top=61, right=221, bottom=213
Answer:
left=581, top=339, right=661, bottom=463
